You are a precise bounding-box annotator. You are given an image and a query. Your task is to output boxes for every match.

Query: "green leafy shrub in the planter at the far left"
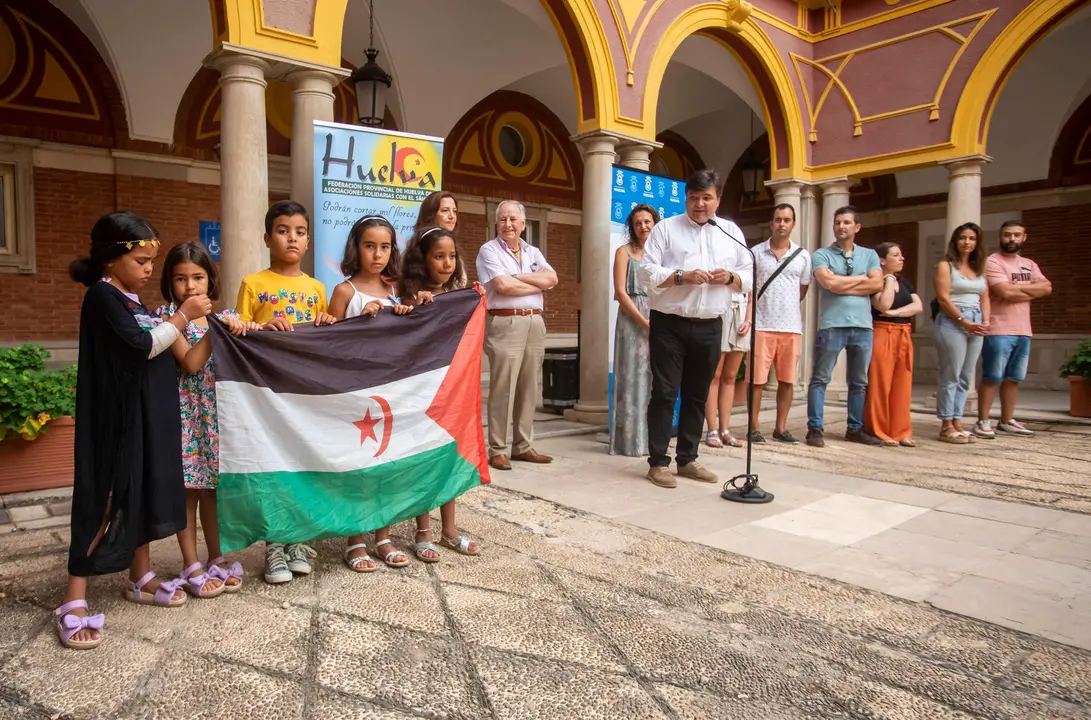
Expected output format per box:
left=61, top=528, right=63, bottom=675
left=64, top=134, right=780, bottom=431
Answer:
left=0, top=344, right=76, bottom=440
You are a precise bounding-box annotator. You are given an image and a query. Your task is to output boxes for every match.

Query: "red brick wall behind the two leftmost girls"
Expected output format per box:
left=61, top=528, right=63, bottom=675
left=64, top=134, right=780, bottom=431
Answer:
left=0, top=168, right=219, bottom=341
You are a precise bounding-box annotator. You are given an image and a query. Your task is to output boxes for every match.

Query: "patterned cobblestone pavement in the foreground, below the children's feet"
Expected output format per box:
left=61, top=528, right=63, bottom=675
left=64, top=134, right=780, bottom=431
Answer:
left=0, top=488, right=1091, bottom=720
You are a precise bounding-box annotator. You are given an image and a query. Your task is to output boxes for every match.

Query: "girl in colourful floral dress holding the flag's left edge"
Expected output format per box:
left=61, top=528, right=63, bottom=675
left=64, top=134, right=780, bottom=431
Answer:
left=158, top=242, right=261, bottom=598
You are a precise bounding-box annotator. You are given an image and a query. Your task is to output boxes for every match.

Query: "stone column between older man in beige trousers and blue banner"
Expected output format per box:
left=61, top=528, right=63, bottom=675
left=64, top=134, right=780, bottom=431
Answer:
left=566, top=132, right=619, bottom=424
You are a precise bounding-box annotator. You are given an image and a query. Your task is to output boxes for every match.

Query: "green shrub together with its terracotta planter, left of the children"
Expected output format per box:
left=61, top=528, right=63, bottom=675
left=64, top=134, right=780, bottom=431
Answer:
left=0, top=344, right=76, bottom=493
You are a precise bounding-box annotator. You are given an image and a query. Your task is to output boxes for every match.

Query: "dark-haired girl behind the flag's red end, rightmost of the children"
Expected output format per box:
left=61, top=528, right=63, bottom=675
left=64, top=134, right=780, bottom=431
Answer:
left=398, top=226, right=481, bottom=556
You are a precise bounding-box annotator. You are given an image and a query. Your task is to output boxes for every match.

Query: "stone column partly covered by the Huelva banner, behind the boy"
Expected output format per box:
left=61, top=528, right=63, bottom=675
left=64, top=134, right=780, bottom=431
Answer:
left=285, top=68, right=348, bottom=275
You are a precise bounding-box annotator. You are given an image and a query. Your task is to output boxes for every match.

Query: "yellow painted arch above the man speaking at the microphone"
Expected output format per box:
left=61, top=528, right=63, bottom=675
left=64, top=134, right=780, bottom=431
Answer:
left=642, top=2, right=805, bottom=179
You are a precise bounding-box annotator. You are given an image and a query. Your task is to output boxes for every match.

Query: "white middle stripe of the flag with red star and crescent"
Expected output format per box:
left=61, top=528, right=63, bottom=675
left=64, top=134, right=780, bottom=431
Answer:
left=216, top=368, right=454, bottom=475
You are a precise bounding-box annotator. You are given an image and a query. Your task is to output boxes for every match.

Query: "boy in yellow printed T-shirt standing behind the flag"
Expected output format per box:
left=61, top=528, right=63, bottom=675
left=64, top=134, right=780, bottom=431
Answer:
left=235, top=200, right=334, bottom=584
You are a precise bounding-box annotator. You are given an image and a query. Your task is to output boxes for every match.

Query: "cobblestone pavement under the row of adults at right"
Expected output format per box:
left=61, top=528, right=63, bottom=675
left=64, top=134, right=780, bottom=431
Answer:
left=700, top=407, right=1091, bottom=513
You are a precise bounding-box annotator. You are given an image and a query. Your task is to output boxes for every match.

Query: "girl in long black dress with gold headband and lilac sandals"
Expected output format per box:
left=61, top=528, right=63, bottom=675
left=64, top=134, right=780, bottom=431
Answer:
left=53, top=213, right=212, bottom=649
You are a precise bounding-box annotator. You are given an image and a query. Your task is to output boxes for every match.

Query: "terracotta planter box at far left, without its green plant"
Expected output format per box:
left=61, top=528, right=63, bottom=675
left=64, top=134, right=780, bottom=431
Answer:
left=0, top=418, right=75, bottom=494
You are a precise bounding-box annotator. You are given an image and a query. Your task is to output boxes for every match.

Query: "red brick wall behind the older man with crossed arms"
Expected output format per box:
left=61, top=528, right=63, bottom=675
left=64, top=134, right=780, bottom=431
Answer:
left=458, top=213, right=579, bottom=333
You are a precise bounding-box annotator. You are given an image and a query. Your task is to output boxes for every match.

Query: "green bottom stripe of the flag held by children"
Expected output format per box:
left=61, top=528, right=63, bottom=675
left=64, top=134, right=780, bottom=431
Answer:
left=216, top=442, right=481, bottom=552
